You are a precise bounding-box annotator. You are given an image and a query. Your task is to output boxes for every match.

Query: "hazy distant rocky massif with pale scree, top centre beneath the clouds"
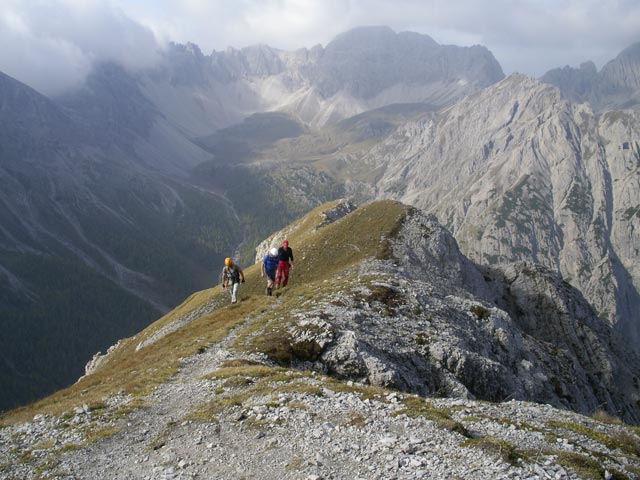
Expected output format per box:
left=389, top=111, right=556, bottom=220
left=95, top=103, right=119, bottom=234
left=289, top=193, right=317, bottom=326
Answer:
left=140, top=27, right=504, bottom=132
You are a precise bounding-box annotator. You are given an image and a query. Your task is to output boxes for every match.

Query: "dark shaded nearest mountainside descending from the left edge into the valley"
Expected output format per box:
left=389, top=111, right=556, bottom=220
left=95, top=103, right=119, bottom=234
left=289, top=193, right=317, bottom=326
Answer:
left=0, top=69, right=240, bottom=406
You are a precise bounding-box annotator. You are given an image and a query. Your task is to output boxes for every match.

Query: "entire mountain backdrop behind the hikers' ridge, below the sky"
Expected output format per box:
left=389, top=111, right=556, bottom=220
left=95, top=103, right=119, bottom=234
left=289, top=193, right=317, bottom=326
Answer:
left=0, top=27, right=640, bottom=408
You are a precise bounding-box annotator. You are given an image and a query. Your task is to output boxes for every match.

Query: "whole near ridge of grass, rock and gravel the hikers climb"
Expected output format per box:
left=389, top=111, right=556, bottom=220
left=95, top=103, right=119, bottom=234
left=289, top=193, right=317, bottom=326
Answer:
left=0, top=201, right=640, bottom=479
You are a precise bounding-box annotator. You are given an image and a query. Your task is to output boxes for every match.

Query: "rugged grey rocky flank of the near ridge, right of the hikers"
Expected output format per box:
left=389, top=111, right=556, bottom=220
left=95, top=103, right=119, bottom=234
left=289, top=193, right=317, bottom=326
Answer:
left=280, top=206, right=640, bottom=423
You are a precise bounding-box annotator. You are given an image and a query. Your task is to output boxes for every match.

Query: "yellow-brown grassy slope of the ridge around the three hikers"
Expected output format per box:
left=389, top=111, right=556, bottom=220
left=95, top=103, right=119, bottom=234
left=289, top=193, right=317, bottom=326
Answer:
left=1, top=201, right=408, bottom=423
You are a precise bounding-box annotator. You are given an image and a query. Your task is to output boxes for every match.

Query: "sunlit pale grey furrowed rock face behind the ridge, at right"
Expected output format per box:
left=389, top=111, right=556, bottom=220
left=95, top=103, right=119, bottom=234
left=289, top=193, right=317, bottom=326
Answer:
left=364, top=75, right=640, bottom=340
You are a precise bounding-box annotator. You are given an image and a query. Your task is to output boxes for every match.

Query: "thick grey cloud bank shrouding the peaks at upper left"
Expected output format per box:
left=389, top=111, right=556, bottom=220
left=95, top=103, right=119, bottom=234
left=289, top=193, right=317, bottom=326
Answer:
left=0, top=0, right=159, bottom=95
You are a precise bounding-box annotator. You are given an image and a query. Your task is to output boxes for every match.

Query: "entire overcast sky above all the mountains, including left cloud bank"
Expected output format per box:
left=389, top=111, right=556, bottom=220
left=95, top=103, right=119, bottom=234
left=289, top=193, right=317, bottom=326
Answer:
left=0, top=0, right=640, bottom=94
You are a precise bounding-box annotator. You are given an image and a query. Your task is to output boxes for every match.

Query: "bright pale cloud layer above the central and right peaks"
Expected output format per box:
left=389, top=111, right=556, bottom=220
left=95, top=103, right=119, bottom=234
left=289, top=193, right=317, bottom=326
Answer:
left=136, top=0, right=640, bottom=76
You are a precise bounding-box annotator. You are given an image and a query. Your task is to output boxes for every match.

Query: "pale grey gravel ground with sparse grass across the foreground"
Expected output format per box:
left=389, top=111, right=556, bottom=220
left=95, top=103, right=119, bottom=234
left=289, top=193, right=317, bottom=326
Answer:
left=0, top=308, right=638, bottom=480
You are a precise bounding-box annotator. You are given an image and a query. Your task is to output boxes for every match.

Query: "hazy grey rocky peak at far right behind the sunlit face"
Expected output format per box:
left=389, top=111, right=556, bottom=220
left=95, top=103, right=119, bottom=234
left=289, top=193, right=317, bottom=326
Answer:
left=541, top=43, right=640, bottom=112
